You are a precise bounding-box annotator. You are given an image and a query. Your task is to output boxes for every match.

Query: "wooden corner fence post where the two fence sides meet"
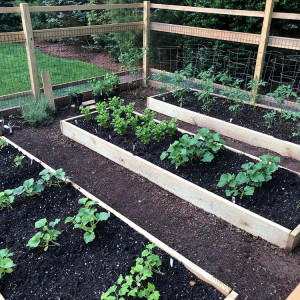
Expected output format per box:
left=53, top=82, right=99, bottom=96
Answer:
left=143, top=1, right=150, bottom=87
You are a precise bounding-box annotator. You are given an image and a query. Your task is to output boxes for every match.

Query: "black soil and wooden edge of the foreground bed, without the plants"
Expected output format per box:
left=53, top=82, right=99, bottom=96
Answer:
left=0, top=139, right=237, bottom=300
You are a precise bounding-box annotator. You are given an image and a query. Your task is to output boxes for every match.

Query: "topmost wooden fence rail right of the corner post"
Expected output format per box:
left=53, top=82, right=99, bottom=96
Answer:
left=151, top=3, right=300, bottom=20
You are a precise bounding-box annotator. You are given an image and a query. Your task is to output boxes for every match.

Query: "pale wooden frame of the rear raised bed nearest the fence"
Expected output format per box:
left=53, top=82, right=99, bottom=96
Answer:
left=147, top=94, right=300, bottom=161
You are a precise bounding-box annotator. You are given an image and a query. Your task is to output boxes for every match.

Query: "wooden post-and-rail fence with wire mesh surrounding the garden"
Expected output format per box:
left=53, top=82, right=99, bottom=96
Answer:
left=0, top=0, right=300, bottom=108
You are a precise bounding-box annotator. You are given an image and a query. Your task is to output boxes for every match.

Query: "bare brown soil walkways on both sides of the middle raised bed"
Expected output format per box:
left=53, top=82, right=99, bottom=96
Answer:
left=6, top=88, right=300, bottom=300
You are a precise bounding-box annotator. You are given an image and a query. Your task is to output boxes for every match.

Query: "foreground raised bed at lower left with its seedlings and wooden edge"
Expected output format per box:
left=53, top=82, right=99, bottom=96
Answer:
left=0, top=138, right=237, bottom=299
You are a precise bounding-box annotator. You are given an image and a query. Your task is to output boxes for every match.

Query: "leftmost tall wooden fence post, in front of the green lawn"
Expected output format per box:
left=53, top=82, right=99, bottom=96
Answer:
left=20, top=3, right=41, bottom=100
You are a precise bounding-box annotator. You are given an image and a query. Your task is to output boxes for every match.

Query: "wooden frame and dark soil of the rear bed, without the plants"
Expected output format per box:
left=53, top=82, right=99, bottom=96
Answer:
left=147, top=92, right=300, bottom=161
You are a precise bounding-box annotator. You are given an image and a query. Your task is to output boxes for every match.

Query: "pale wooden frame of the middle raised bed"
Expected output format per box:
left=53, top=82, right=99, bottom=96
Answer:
left=61, top=113, right=300, bottom=251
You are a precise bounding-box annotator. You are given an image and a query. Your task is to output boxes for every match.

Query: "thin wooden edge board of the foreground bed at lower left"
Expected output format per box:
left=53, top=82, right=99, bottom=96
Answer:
left=0, top=137, right=238, bottom=300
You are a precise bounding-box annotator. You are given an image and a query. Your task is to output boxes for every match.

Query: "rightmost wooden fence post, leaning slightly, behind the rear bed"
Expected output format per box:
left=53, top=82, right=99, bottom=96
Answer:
left=252, top=0, right=274, bottom=102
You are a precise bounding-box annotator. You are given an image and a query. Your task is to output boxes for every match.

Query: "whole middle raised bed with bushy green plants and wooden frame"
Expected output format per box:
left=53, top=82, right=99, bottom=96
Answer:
left=61, top=97, right=300, bottom=250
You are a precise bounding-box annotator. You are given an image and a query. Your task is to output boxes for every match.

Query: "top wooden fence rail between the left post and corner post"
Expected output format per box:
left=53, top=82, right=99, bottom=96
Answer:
left=30, top=3, right=143, bottom=12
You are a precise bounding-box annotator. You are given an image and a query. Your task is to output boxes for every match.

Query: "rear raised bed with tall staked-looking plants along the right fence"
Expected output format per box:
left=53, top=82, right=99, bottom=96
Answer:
left=148, top=68, right=300, bottom=160
